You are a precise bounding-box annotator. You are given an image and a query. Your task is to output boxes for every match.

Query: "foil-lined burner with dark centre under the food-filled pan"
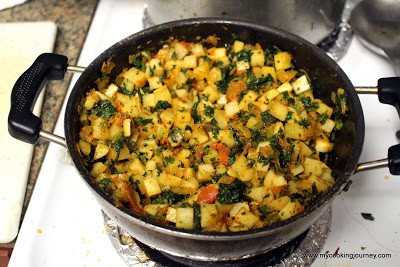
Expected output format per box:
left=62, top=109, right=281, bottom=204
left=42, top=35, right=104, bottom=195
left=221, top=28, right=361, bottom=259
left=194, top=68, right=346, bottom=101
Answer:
left=102, top=208, right=332, bottom=267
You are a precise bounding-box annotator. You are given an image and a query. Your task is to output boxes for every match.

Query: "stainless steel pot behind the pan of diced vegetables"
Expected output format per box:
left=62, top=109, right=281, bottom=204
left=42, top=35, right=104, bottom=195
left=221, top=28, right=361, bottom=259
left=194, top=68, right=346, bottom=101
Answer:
left=146, top=0, right=346, bottom=44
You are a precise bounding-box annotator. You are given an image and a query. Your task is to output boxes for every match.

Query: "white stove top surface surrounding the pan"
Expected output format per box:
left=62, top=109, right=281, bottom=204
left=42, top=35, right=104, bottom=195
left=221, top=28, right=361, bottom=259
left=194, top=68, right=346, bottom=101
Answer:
left=9, top=0, right=400, bottom=267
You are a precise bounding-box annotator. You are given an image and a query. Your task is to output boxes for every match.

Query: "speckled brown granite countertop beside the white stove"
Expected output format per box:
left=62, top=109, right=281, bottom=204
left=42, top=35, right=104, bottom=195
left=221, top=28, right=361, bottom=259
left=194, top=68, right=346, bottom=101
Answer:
left=0, top=0, right=98, bottom=246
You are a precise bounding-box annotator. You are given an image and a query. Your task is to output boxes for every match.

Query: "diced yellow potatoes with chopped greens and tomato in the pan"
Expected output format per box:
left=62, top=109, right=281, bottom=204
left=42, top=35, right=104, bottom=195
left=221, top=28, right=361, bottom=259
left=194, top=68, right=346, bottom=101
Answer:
left=78, top=36, right=347, bottom=232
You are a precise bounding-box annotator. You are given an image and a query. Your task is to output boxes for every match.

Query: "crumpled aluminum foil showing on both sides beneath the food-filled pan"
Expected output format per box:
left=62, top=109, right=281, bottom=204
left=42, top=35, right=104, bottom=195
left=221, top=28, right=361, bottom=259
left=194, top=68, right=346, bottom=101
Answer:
left=102, top=208, right=332, bottom=267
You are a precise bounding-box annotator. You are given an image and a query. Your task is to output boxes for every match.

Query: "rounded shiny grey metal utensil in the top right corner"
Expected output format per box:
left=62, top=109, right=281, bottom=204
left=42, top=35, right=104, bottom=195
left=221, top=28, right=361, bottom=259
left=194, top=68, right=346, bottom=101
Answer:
left=350, top=0, right=400, bottom=75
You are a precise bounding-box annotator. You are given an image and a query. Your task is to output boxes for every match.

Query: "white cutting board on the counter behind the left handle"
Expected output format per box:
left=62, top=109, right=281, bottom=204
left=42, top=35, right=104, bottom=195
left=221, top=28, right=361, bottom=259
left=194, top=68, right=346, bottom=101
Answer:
left=0, top=22, right=57, bottom=243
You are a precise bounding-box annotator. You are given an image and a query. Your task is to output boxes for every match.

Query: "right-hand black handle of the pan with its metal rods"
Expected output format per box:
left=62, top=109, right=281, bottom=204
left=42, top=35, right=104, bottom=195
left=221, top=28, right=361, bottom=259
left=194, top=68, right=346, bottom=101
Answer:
left=356, top=77, right=400, bottom=175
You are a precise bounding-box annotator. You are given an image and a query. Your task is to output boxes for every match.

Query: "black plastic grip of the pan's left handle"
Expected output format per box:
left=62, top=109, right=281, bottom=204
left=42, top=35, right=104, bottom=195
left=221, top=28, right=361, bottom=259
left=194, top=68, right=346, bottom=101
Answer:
left=8, top=53, right=68, bottom=144
